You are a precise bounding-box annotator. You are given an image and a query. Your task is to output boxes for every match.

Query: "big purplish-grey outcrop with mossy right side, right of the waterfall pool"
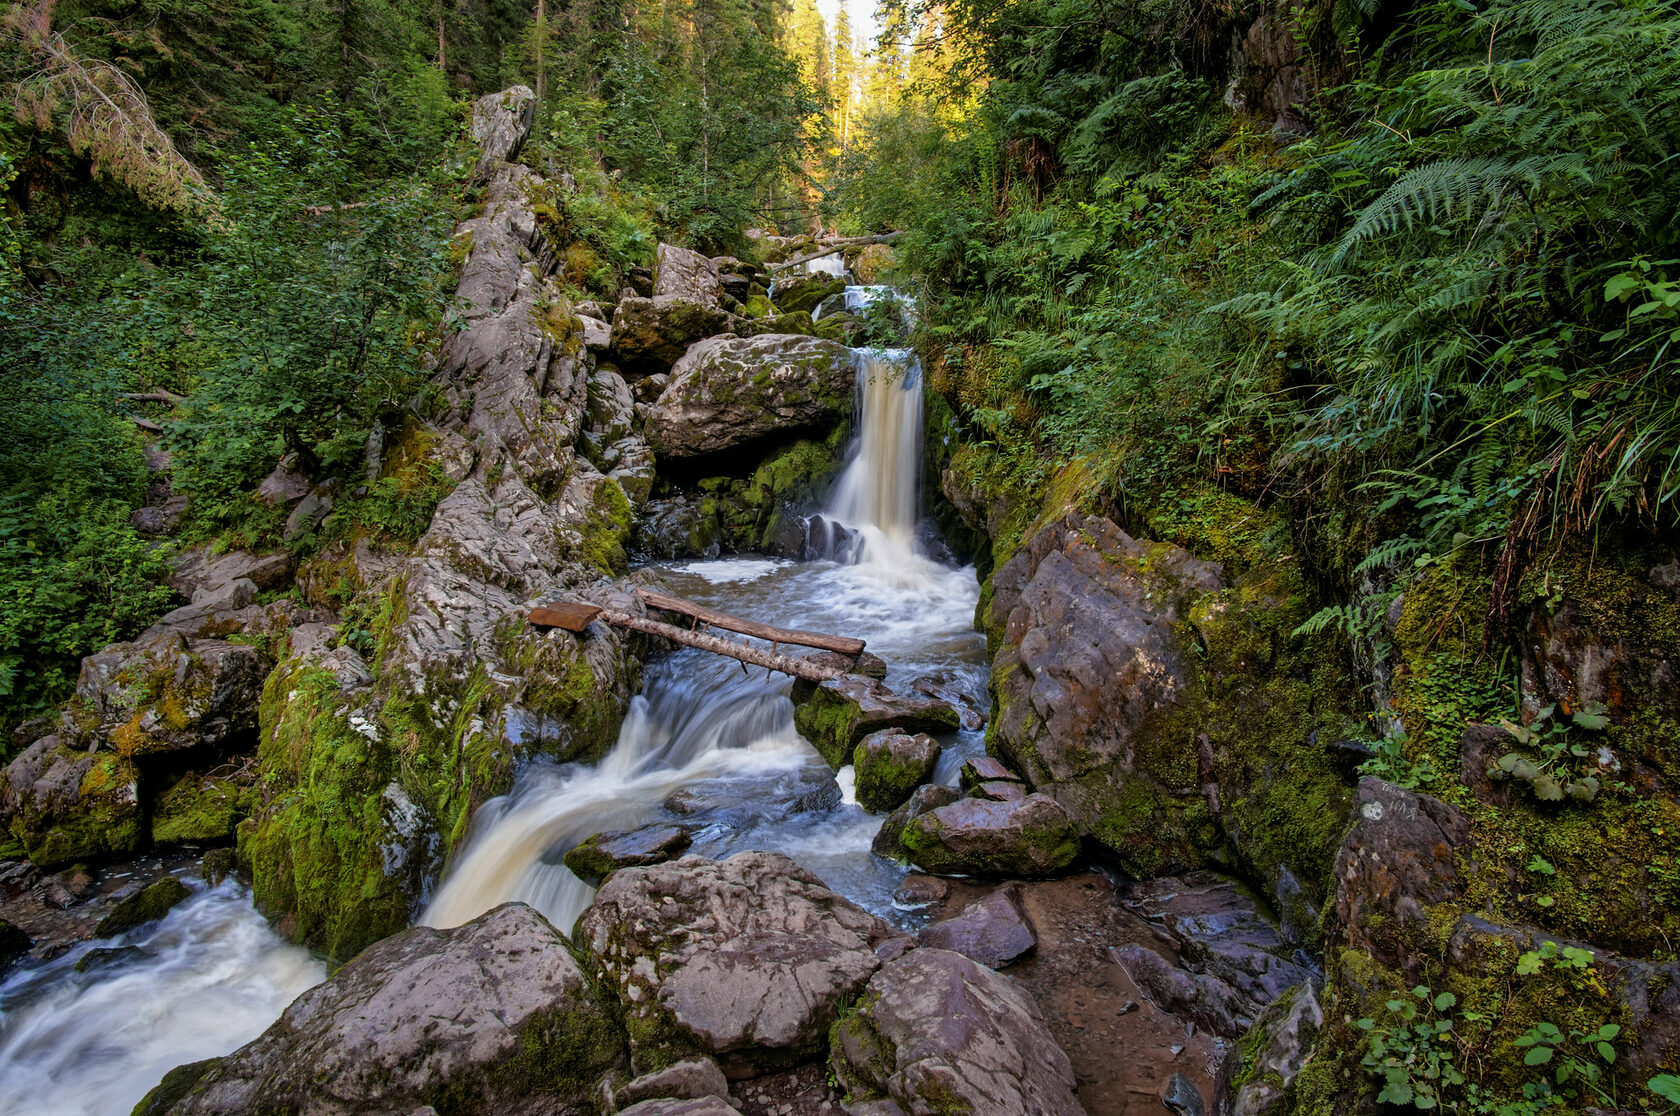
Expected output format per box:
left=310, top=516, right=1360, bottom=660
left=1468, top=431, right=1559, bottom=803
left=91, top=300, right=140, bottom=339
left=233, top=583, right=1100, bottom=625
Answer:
left=983, top=511, right=1351, bottom=936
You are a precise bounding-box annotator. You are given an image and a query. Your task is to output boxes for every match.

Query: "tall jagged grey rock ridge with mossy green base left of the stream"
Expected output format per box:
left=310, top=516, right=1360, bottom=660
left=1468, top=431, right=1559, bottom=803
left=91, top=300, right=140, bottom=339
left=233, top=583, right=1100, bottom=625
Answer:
left=240, top=87, right=652, bottom=958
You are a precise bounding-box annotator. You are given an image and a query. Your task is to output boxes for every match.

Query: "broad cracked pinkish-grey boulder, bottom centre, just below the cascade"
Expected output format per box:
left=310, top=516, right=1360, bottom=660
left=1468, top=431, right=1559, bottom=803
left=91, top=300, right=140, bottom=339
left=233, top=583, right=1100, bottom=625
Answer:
left=578, top=852, right=892, bottom=1076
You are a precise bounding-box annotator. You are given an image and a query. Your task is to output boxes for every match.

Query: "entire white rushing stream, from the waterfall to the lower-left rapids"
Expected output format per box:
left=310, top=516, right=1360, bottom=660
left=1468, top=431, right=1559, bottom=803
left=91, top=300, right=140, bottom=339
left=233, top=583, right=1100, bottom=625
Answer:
left=0, top=287, right=984, bottom=1116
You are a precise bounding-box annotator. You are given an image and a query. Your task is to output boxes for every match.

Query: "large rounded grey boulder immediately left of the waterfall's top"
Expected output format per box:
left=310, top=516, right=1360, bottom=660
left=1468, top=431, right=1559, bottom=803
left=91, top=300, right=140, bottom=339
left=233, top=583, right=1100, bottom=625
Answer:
left=648, top=334, right=857, bottom=459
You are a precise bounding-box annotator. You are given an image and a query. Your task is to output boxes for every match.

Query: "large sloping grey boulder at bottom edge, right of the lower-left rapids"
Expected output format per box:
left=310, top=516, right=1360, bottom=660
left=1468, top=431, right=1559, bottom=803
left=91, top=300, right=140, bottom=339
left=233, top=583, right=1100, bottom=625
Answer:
left=136, top=903, right=625, bottom=1116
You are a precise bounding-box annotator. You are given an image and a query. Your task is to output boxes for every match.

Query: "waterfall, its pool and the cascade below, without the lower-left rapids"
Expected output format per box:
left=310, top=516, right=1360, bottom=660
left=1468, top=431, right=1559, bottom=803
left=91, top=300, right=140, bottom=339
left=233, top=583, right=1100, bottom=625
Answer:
left=409, top=285, right=981, bottom=929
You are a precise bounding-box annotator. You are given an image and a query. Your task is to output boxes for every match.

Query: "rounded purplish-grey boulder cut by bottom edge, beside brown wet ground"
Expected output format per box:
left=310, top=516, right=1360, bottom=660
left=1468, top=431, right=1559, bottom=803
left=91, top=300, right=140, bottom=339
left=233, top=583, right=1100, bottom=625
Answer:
left=830, top=948, right=1084, bottom=1116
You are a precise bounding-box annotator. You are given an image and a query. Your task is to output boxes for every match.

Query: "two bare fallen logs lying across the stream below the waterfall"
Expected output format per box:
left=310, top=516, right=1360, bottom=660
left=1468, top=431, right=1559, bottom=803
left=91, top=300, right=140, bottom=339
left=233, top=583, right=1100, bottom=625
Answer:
left=529, top=588, right=864, bottom=682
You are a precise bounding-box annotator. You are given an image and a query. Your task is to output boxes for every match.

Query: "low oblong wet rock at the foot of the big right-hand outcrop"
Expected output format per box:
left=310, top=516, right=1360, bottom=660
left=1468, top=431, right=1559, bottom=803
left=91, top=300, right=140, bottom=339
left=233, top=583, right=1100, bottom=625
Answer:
left=900, top=793, right=1079, bottom=879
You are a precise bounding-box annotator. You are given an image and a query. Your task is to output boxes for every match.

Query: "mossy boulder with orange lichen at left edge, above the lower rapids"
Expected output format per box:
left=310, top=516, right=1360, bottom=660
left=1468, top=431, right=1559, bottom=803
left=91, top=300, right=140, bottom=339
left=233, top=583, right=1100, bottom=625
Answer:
left=0, top=734, right=146, bottom=869
